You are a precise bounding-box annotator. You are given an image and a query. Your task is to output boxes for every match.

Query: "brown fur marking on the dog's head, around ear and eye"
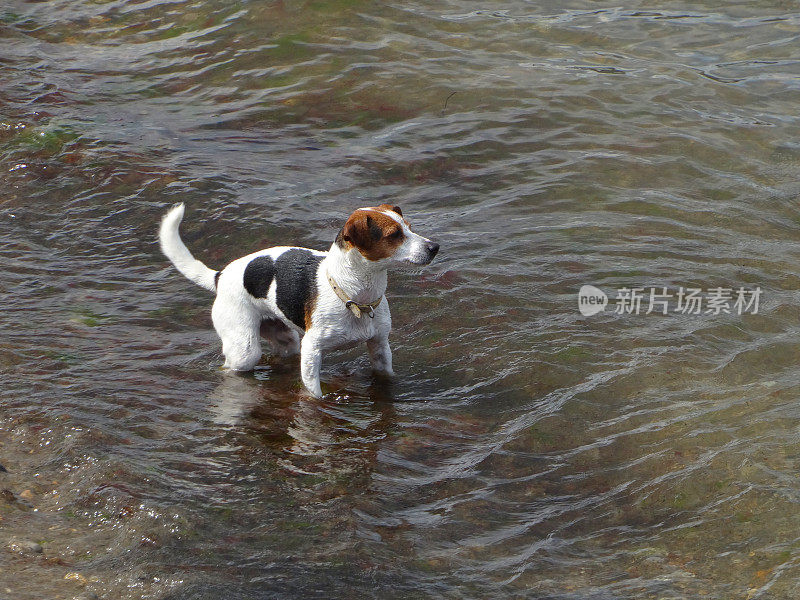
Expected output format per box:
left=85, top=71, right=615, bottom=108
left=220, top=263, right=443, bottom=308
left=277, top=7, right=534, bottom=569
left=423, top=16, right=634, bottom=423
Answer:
left=336, top=204, right=405, bottom=261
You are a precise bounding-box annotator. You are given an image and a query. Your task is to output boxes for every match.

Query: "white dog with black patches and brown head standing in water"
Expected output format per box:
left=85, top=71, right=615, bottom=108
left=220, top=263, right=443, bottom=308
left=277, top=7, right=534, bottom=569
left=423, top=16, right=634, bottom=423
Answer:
left=159, top=204, right=439, bottom=397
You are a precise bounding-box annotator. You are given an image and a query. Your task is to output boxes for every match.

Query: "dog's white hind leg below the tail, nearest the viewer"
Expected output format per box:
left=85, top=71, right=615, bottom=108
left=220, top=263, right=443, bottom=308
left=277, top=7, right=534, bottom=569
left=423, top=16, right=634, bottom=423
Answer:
left=211, top=294, right=261, bottom=371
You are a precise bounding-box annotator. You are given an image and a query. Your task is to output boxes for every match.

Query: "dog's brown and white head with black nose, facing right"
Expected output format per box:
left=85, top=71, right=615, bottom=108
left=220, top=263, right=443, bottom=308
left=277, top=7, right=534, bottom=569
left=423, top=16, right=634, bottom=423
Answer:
left=336, top=204, right=439, bottom=266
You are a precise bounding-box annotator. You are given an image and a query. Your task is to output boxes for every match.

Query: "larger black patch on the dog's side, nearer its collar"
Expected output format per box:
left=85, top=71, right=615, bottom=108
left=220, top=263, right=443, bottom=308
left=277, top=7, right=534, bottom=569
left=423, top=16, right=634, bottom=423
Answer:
left=275, top=248, right=325, bottom=329
